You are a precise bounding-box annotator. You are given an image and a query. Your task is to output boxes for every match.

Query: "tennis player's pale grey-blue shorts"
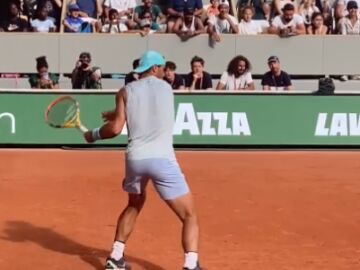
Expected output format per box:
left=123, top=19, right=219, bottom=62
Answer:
left=123, top=158, right=189, bottom=200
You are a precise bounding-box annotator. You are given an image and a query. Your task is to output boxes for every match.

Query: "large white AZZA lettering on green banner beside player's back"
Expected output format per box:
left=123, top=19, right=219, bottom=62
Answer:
left=174, top=103, right=251, bottom=136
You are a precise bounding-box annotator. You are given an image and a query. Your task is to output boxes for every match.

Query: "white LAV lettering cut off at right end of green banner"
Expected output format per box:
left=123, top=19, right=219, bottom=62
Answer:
left=315, top=113, right=360, bottom=136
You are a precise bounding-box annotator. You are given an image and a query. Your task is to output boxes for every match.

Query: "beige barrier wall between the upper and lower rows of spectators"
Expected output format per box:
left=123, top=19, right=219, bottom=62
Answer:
left=0, top=33, right=360, bottom=75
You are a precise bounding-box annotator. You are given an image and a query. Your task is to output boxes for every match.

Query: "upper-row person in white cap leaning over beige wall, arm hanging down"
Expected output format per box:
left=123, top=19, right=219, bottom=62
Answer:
left=208, top=1, right=239, bottom=42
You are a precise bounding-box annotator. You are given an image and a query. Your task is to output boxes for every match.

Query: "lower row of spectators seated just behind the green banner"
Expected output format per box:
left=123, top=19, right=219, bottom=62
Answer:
left=29, top=52, right=292, bottom=91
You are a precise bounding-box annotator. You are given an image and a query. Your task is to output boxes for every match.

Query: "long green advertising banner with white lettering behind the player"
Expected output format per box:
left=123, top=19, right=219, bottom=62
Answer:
left=0, top=93, right=360, bottom=146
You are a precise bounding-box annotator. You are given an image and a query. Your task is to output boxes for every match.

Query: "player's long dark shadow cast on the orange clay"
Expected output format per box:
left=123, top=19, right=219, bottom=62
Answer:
left=0, top=221, right=165, bottom=270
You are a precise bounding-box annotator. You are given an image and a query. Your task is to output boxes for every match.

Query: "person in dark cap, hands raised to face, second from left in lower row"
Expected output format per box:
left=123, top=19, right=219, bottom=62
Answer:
left=71, top=52, right=102, bottom=89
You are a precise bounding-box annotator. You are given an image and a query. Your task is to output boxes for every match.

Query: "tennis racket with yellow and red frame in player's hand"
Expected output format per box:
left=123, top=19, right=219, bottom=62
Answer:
left=45, top=96, right=88, bottom=133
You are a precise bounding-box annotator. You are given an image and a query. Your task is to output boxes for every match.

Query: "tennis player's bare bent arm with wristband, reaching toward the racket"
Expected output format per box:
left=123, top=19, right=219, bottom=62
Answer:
left=84, top=88, right=126, bottom=143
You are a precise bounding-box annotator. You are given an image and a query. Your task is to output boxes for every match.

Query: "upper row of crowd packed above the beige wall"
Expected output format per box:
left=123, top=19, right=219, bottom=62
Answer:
left=0, top=0, right=360, bottom=35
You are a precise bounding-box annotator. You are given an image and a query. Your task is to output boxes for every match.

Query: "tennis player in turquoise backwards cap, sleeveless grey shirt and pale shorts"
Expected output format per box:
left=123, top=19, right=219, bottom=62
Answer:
left=84, top=51, right=201, bottom=270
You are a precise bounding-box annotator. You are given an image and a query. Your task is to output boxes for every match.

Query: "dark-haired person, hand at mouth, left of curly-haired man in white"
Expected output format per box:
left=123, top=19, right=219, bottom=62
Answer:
left=185, top=56, right=212, bottom=90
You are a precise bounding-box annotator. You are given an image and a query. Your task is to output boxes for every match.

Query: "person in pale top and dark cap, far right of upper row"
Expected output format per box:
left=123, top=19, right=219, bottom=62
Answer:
left=339, top=1, right=360, bottom=35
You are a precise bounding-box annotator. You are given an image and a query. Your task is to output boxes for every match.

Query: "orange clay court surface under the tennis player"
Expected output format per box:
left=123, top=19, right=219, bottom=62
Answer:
left=0, top=150, right=360, bottom=270
